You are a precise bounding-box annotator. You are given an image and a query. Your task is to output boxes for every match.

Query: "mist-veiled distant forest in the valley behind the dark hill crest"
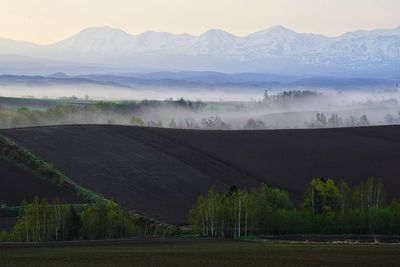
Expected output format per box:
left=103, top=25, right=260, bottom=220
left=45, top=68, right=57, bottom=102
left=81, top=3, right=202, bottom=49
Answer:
left=0, top=91, right=400, bottom=130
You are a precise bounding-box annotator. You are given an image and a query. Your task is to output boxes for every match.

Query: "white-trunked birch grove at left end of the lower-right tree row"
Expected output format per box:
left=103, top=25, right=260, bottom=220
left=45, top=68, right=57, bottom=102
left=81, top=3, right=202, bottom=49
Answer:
left=188, top=185, right=292, bottom=238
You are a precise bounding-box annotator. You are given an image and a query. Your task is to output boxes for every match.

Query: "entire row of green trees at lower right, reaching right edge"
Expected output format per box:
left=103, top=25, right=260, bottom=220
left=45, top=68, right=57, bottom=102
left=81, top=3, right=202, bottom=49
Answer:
left=188, top=178, right=400, bottom=238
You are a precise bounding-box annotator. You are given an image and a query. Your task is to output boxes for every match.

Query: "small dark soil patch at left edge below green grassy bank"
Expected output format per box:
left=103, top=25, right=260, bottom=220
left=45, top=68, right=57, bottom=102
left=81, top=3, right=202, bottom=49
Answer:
left=0, top=160, right=78, bottom=206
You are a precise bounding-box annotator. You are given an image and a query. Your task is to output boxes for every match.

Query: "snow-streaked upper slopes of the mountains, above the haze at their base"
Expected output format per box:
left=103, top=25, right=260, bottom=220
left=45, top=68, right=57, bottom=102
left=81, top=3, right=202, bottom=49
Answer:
left=0, top=25, right=400, bottom=76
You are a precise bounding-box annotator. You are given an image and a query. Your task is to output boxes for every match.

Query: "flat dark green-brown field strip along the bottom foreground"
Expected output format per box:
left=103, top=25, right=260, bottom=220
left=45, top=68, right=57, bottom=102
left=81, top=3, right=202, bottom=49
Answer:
left=0, top=240, right=400, bottom=267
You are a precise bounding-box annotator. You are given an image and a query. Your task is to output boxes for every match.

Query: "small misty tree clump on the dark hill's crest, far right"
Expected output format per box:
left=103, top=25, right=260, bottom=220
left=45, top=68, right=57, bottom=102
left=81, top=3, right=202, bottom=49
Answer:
left=304, top=113, right=370, bottom=128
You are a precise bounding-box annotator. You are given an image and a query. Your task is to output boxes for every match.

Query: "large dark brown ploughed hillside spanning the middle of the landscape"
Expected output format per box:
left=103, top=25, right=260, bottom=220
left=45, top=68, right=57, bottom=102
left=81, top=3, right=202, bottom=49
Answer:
left=1, top=125, right=400, bottom=223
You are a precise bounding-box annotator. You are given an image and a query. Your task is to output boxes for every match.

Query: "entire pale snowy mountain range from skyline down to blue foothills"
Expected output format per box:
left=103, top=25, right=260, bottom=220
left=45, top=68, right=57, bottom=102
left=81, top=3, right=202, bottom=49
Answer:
left=0, top=26, right=400, bottom=79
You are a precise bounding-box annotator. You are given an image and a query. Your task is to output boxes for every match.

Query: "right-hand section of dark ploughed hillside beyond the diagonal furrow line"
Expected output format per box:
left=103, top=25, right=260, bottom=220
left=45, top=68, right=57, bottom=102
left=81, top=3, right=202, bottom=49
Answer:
left=149, top=126, right=400, bottom=203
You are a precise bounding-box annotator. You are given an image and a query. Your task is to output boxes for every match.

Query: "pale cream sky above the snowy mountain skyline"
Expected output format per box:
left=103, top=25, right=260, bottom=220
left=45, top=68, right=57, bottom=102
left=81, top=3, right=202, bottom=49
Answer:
left=0, top=0, right=400, bottom=44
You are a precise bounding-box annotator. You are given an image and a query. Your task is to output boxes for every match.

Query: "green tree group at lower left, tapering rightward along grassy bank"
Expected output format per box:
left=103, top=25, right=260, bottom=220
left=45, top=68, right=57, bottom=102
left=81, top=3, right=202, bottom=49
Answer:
left=0, top=197, right=173, bottom=242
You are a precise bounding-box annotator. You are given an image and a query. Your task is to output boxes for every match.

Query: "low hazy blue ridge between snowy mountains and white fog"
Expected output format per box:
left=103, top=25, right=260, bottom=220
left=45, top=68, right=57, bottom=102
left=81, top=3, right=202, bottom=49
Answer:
left=0, top=71, right=399, bottom=92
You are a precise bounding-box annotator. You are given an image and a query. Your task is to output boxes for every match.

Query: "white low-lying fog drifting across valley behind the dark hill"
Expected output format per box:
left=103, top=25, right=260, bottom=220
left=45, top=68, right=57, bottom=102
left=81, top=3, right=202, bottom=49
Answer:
left=0, top=85, right=400, bottom=129
